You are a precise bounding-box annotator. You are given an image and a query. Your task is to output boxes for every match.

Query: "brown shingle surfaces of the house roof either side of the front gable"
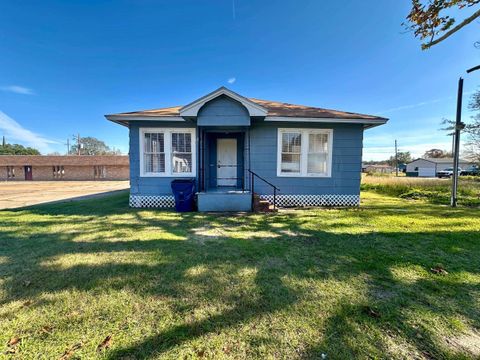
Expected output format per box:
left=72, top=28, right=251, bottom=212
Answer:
left=107, top=98, right=387, bottom=120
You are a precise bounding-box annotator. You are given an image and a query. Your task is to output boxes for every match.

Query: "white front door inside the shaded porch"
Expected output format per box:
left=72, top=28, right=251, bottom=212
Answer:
left=217, top=139, right=237, bottom=186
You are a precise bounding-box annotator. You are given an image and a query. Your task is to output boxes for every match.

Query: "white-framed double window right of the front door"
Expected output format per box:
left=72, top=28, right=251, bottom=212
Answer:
left=277, top=129, right=333, bottom=177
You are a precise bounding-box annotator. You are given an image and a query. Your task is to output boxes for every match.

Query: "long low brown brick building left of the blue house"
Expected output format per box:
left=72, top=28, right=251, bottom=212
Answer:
left=0, top=155, right=129, bottom=181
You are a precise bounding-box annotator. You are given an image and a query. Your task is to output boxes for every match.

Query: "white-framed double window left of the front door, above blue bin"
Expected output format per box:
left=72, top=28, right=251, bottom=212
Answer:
left=140, top=128, right=195, bottom=176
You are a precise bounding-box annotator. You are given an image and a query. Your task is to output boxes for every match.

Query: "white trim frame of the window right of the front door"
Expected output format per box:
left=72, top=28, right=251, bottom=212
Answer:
left=277, top=128, right=333, bottom=178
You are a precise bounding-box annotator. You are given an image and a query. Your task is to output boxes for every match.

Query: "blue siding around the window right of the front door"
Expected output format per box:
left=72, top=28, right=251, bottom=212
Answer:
left=250, top=121, right=363, bottom=195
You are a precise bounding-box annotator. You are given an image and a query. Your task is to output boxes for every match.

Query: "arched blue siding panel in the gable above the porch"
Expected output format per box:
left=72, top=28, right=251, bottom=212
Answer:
left=197, top=95, right=250, bottom=126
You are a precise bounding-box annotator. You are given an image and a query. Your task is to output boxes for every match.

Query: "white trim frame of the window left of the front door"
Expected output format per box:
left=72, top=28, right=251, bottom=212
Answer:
left=138, top=127, right=197, bottom=178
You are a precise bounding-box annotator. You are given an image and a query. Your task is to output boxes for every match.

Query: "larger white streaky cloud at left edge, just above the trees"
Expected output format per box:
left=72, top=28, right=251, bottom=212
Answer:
left=0, top=111, right=61, bottom=153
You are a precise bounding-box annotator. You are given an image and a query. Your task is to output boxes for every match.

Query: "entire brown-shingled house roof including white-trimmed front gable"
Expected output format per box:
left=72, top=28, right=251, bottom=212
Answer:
left=105, top=87, right=388, bottom=126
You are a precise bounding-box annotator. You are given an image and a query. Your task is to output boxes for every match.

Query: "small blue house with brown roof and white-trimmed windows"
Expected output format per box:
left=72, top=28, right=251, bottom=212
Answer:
left=106, top=87, right=387, bottom=211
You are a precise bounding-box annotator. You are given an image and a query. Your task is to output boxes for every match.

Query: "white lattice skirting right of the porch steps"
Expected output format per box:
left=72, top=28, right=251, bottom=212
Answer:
left=260, top=194, right=360, bottom=207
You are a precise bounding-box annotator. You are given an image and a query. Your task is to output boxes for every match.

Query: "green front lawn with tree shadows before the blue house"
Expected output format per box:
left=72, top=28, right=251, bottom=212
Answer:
left=0, top=192, right=480, bottom=359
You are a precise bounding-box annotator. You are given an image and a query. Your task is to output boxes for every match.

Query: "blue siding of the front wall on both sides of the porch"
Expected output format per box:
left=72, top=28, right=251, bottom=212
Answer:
left=130, top=118, right=363, bottom=195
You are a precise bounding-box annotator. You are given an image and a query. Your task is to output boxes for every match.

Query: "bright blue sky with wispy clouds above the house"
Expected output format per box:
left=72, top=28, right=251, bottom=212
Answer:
left=0, top=0, right=480, bottom=160
